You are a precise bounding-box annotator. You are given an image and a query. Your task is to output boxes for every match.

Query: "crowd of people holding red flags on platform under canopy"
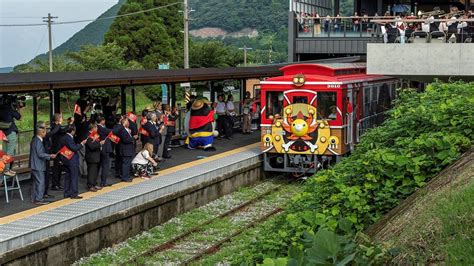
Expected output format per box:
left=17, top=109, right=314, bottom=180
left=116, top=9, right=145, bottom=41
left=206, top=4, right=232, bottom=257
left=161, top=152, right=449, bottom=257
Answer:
left=0, top=93, right=262, bottom=205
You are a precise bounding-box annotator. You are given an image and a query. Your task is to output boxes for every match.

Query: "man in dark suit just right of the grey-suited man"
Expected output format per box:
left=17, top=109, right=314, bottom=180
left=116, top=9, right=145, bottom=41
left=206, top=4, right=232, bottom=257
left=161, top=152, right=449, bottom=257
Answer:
left=61, top=125, right=86, bottom=199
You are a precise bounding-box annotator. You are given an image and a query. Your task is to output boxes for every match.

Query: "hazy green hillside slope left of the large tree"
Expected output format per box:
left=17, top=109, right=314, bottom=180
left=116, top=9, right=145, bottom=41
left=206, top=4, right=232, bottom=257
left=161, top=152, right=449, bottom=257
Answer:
left=31, top=0, right=126, bottom=62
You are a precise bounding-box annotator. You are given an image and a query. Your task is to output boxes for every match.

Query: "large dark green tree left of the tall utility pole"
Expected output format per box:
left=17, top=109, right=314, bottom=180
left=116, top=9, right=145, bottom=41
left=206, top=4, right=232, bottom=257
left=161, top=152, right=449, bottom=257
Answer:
left=105, top=0, right=183, bottom=69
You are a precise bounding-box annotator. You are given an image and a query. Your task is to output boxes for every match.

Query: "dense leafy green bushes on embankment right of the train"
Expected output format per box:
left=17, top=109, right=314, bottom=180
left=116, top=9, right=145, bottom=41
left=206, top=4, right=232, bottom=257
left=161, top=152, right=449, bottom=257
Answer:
left=243, top=82, right=474, bottom=261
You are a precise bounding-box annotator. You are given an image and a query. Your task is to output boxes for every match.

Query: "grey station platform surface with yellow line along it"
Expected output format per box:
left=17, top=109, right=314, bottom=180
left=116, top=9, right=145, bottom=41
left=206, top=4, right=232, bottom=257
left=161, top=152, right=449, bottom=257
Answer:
left=0, top=133, right=261, bottom=265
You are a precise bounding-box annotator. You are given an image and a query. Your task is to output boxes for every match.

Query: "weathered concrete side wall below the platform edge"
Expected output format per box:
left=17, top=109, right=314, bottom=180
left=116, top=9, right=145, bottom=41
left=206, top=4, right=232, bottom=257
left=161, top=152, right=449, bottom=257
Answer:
left=1, top=161, right=264, bottom=266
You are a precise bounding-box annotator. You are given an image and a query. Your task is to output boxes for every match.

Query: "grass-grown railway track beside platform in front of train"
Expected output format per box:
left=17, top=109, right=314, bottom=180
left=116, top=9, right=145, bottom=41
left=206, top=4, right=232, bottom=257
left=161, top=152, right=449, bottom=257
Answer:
left=121, top=184, right=292, bottom=265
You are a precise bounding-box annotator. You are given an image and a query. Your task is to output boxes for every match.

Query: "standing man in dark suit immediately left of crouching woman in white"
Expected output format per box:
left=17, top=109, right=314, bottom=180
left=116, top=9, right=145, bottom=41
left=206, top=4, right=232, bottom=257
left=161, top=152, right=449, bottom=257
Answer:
left=117, top=118, right=135, bottom=182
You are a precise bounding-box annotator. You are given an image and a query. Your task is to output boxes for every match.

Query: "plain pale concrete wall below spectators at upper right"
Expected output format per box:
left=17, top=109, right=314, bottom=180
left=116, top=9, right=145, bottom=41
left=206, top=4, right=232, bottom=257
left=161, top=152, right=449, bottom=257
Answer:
left=367, top=43, right=474, bottom=78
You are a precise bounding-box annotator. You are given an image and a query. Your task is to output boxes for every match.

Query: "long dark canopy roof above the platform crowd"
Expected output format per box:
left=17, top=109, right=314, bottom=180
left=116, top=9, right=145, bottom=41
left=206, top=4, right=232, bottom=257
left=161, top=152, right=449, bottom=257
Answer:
left=0, top=56, right=360, bottom=93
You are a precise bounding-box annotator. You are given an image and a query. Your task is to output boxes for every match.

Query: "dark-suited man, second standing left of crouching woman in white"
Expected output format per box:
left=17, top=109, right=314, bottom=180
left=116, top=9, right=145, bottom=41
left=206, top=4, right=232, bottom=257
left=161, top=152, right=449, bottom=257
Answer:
left=97, top=116, right=114, bottom=187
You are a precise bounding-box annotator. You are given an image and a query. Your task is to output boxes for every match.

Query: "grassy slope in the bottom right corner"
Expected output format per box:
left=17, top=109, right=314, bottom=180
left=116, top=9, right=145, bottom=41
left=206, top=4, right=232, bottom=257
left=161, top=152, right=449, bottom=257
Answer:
left=390, top=172, right=474, bottom=265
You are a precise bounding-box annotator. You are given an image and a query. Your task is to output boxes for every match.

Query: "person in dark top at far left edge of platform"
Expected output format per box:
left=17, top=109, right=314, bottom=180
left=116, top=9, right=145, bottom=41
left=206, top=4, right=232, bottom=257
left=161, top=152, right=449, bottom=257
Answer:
left=0, top=95, right=25, bottom=175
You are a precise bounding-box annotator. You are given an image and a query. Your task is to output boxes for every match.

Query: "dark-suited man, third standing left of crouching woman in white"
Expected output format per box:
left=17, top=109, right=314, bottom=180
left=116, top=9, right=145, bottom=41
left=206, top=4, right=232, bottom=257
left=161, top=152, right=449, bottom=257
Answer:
left=86, top=124, right=105, bottom=192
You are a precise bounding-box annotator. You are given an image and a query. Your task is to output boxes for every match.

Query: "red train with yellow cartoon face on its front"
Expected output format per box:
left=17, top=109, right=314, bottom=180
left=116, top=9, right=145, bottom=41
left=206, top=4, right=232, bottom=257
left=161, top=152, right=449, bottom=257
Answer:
left=260, top=63, right=398, bottom=175
